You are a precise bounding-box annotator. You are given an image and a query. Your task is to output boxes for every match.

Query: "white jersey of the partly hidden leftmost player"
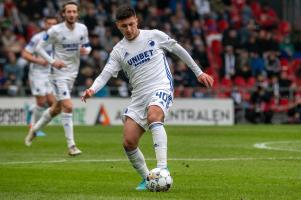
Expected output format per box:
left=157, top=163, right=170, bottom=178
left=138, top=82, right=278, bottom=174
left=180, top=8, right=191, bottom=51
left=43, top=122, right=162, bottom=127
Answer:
left=25, top=31, right=52, bottom=79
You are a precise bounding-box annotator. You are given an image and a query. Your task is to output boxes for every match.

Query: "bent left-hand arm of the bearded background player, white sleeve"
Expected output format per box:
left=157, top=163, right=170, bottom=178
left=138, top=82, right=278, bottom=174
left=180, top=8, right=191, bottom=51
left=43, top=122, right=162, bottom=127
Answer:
left=36, top=28, right=66, bottom=69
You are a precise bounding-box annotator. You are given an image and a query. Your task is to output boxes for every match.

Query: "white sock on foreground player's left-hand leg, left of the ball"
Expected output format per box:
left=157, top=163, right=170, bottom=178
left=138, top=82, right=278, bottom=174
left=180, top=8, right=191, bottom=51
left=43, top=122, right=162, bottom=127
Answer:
left=125, top=148, right=149, bottom=179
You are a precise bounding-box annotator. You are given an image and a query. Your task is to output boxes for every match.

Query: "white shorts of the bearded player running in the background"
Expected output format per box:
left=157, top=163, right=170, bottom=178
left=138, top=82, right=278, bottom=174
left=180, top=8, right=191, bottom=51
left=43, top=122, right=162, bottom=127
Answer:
left=50, top=78, right=74, bottom=101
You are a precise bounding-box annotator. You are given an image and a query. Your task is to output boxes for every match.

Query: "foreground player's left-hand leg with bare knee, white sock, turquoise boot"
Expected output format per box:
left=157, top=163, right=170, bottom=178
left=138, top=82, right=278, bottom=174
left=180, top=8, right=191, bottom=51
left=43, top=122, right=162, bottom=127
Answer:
left=123, top=117, right=149, bottom=190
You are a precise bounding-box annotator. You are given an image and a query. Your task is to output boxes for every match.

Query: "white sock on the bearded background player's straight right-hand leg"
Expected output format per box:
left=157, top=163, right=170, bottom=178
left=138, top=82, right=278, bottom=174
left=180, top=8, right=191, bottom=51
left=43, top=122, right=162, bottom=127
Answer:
left=61, top=112, right=75, bottom=148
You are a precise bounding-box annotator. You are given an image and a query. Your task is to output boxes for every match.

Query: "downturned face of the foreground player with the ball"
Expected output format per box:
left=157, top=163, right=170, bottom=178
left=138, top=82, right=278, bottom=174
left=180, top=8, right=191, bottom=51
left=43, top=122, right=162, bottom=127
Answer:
left=116, top=16, right=139, bottom=40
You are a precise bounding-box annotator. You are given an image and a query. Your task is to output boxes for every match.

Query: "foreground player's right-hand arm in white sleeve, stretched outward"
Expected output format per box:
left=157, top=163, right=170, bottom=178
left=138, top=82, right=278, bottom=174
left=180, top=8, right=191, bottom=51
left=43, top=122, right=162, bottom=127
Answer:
left=156, top=31, right=214, bottom=88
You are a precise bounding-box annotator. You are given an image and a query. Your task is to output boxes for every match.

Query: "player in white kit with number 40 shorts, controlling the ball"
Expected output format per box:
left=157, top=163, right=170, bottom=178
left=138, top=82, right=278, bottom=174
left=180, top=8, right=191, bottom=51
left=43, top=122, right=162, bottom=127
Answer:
left=82, top=5, right=213, bottom=190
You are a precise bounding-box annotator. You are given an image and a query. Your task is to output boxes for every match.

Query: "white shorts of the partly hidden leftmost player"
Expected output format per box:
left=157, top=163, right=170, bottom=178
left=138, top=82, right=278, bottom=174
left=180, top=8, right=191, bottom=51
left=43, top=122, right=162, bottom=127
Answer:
left=29, top=76, right=53, bottom=96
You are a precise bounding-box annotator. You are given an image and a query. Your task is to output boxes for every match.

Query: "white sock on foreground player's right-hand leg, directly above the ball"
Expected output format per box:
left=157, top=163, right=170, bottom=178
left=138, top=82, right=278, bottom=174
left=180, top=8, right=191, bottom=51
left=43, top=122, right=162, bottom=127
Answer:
left=149, top=122, right=167, bottom=168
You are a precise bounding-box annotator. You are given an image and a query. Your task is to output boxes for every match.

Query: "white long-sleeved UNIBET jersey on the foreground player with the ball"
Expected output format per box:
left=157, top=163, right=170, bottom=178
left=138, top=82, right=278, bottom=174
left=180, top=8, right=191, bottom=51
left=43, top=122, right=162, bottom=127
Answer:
left=99, top=30, right=202, bottom=97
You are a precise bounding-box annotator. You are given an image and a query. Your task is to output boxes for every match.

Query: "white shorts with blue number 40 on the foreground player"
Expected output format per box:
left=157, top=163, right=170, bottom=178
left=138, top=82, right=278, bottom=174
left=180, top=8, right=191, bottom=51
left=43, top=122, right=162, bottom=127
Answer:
left=123, top=90, right=173, bottom=130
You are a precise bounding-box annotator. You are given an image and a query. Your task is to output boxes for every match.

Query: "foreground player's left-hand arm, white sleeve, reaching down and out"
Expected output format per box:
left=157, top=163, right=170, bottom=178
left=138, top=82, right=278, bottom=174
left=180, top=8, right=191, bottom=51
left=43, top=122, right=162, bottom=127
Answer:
left=81, top=50, right=121, bottom=102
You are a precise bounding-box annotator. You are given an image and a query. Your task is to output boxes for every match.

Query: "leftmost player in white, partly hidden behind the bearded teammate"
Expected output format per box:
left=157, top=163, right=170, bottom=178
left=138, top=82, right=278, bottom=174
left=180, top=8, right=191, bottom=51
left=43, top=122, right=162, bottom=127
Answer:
left=22, top=16, right=58, bottom=134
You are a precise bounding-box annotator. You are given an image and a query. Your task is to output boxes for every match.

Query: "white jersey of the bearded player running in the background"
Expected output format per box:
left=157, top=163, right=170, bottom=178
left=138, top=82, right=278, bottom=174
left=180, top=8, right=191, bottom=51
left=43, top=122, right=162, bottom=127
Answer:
left=38, top=22, right=89, bottom=79
